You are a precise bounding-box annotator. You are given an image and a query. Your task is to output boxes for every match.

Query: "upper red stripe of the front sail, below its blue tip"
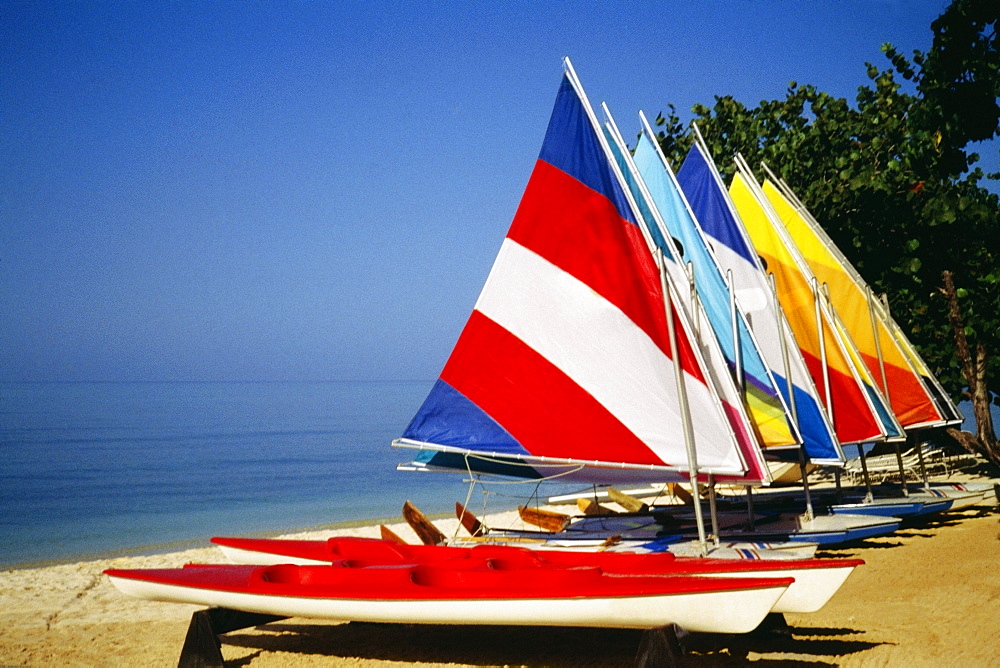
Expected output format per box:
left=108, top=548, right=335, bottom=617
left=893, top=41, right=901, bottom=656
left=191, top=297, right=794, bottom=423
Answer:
left=507, top=160, right=705, bottom=383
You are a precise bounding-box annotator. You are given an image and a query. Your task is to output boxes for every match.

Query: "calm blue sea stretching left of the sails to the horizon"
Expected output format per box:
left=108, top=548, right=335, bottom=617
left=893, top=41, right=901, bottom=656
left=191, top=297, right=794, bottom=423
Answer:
left=0, top=381, right=516, bottom=565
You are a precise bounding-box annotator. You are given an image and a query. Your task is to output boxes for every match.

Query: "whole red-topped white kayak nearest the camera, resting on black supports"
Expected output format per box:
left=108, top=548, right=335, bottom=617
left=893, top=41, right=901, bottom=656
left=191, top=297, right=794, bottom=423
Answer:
left=105, top=557, right=792, bottom=633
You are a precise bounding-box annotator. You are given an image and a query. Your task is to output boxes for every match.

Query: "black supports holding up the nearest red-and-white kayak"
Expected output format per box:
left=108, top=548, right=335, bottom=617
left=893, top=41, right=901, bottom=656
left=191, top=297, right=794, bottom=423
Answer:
left=177, top=608, right=744, bottom=668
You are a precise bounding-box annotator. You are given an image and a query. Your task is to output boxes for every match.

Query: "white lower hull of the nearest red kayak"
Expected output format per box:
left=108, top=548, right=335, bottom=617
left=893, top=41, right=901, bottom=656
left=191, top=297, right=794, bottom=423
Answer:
left=101, top=566, right=789, bottom=633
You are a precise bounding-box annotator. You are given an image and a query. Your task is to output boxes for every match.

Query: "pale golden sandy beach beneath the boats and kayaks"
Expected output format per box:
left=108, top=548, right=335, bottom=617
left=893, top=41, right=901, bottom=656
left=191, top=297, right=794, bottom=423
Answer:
left=0, top=474, right=1000, bottom=667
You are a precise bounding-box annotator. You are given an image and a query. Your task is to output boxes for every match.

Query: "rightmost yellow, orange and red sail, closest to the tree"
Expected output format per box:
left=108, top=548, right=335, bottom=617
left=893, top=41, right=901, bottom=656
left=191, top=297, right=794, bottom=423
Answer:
left=763, top=180, right=943, bottom=428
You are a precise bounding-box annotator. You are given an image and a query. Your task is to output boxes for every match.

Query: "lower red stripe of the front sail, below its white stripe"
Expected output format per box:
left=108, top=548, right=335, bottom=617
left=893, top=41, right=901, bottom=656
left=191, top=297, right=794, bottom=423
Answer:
left=441, top=311, right=664, bottom=465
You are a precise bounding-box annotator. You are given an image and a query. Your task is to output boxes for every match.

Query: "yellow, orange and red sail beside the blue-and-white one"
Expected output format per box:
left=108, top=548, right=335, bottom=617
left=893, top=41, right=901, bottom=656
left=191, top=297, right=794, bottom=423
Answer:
left=729, top=172, right=888, bottom=443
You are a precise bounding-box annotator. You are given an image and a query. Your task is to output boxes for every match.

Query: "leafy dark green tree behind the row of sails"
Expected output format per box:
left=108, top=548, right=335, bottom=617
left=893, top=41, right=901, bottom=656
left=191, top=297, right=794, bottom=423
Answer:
left=657, top=0, right=1000, bottom=463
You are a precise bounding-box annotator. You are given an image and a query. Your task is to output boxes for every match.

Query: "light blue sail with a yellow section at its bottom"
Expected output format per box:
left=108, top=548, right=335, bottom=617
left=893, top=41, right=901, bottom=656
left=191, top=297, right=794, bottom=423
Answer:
left=620, top=122, right=801, bottom=451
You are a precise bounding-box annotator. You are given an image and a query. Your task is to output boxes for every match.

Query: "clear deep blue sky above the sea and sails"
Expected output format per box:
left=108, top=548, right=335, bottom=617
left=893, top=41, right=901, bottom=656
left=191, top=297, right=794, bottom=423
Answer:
left=0, top=0, right=980, bottom=381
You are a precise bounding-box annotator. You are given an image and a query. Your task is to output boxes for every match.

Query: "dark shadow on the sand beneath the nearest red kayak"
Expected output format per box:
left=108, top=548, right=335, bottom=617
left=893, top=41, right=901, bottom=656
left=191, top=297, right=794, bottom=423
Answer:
left=219, top=620, right=878, bottom=668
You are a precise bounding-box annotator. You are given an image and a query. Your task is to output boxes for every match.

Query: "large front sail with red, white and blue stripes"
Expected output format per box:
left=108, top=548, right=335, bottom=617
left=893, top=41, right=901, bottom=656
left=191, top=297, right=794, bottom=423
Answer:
left=394, top=65, right=762, bottom=482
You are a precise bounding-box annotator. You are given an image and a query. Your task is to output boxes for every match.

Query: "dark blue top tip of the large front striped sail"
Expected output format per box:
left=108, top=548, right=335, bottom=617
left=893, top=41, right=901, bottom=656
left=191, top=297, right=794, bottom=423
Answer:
left=538, top=76, right=636, bottom=223
